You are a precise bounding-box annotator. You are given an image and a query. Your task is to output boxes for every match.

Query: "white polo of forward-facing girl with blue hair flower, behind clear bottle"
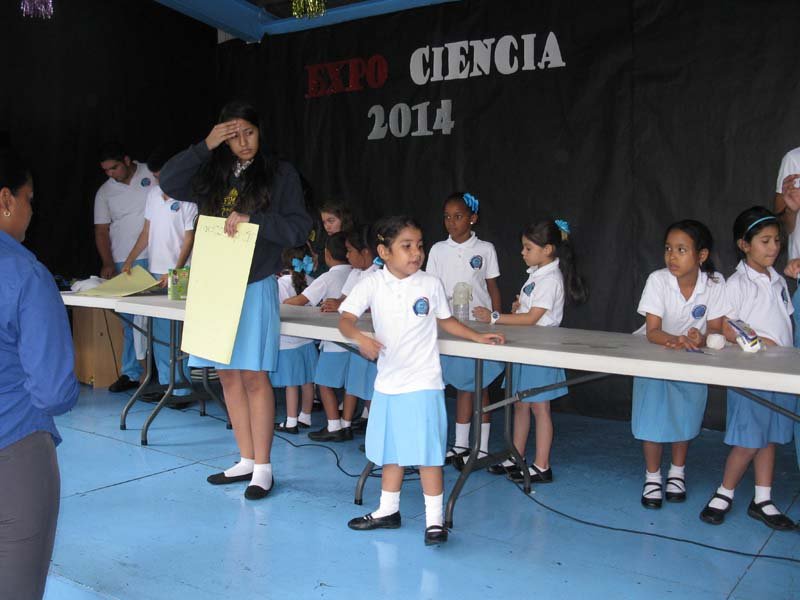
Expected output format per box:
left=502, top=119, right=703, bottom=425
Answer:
left=425, top=231, right=500, bottom=320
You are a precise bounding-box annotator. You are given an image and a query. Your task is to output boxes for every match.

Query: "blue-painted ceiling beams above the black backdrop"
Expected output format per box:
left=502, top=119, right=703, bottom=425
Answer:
left=156, top=0, right=461, bottom=42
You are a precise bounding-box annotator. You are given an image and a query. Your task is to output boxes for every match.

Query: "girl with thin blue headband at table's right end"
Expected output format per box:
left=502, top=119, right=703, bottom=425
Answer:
left=700, top=206, right=797, bottom=530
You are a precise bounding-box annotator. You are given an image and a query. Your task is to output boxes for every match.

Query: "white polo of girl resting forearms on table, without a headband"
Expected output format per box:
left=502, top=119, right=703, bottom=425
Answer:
left=635, top=268, right=730, bottom=335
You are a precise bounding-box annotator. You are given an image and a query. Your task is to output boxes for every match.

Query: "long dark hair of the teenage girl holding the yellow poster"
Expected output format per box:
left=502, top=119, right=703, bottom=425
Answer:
left=192, top=101, right=277, bottom=216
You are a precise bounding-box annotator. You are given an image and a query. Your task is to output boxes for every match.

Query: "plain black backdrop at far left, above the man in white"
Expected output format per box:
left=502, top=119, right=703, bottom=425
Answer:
left=0, top=0, right=217, bottom=277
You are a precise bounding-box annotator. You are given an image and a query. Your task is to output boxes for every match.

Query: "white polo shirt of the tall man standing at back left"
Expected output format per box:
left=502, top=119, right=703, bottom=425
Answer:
left=94, top=161, right=155, bottom=263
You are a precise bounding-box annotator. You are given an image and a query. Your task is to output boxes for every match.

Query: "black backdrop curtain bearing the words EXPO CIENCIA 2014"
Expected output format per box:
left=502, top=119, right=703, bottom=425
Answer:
left=217, top=0, right=800, bottom=426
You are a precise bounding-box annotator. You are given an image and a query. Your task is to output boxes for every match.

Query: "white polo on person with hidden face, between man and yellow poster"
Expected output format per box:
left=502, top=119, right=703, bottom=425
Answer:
left=144, top=185, right=197, bottom=275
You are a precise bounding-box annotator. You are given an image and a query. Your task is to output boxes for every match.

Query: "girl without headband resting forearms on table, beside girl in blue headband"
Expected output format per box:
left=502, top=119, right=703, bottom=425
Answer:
left=631, top=220, right=728, bottom=508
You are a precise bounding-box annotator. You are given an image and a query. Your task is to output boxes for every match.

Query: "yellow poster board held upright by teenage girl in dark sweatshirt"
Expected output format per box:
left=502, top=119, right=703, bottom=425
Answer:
left=181, top=216, right=258, bottom=365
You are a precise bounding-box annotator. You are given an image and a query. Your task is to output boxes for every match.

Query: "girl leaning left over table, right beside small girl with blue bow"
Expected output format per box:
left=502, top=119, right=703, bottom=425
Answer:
left=284, top=232, right=353, bottom=442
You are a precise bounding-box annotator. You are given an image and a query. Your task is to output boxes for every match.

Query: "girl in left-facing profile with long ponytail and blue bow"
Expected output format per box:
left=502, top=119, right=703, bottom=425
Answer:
left=473, top=219, right=589, bottom=483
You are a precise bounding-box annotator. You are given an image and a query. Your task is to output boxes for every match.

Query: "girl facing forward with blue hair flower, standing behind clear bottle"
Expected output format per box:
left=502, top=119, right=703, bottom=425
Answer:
left=425, top=192, right=505, bottom=468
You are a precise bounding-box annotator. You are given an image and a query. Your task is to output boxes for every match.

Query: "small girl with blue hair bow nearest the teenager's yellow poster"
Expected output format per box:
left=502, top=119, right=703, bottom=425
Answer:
left=272, top=246, right=319, bottom=434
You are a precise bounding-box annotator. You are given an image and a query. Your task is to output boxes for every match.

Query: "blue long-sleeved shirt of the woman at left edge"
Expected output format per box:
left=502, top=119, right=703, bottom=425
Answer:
left=0, top=231, right=78, bottom=449
